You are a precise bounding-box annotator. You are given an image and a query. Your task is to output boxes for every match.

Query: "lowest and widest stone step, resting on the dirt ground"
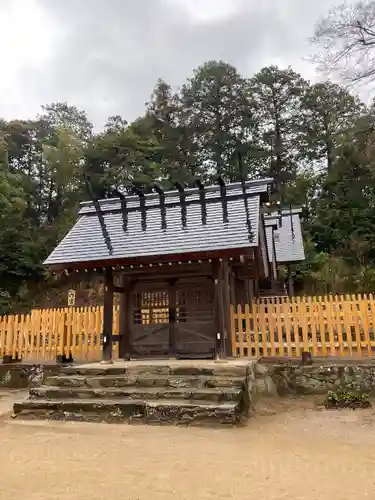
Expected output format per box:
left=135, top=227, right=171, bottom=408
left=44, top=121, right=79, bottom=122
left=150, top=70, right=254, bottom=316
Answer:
left=13, top=399, right=241, bottom=425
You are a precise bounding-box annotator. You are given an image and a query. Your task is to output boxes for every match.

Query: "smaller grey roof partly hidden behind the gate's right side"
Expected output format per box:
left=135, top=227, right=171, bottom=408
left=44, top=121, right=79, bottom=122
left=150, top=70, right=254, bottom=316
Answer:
left=264, top=209, right=305, bottom=263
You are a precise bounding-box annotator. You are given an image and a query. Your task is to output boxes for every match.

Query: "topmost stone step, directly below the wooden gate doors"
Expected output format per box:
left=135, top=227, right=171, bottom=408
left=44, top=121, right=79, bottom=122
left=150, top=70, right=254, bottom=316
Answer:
left=62, top=361, right=249, bottom=377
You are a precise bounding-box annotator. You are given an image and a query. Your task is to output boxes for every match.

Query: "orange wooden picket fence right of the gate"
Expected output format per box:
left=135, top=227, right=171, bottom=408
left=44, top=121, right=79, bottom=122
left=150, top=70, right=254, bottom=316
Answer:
left=231, top=295, right=375, bottom=357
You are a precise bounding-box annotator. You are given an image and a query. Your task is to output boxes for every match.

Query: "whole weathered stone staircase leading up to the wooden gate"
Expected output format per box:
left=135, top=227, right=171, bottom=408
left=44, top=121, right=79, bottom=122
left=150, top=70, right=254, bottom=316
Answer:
left=14, top=361, right=254, bottom=425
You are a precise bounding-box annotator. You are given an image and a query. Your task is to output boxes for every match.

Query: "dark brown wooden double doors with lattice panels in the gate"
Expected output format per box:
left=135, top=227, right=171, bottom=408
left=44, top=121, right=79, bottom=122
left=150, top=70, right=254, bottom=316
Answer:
left=130, top=279, right=216, bottom=358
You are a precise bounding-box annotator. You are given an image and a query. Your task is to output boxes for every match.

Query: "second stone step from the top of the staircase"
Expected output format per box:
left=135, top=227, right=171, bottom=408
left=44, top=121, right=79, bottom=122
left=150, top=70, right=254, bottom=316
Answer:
left=44, top=374, right=245, bottom=389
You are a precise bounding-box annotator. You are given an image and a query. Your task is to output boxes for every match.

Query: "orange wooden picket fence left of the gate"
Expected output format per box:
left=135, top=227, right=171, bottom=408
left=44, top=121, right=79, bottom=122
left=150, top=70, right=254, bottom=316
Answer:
left=0, top=307, right=119, bottom=361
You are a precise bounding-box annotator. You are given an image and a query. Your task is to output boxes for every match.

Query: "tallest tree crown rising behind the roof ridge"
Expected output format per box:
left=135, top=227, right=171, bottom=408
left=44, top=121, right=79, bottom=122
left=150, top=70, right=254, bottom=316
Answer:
left=180, top=61, right=256, bottom=182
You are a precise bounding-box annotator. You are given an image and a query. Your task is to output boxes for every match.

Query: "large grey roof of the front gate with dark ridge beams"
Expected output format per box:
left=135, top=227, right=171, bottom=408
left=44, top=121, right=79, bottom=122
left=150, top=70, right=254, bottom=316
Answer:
left=45, top=179, right=272, bottom=265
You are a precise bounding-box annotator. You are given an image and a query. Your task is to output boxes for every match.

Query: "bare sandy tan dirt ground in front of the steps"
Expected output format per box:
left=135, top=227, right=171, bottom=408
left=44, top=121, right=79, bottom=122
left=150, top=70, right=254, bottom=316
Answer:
left=0, top=399, right=375, bottom=500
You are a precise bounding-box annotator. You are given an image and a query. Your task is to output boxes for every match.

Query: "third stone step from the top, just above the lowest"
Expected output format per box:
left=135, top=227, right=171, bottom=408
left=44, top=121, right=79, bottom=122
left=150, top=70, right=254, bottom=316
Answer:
left=29, top=386, right=241, bottom=403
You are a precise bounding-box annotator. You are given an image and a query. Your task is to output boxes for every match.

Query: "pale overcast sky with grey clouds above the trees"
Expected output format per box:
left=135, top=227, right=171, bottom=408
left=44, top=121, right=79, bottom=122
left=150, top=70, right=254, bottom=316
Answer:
left=0, top=0, right=341, bottom=127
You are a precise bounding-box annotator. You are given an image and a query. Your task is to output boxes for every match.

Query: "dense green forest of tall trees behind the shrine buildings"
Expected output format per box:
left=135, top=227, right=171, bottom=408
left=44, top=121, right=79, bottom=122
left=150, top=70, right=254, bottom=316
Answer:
left=0, top=49, right=375, bottom=313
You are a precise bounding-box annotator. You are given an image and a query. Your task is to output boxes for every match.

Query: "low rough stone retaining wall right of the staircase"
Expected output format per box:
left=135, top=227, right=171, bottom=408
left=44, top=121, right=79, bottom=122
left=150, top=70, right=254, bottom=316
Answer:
left=253, top=361, right=375, bottom=399
